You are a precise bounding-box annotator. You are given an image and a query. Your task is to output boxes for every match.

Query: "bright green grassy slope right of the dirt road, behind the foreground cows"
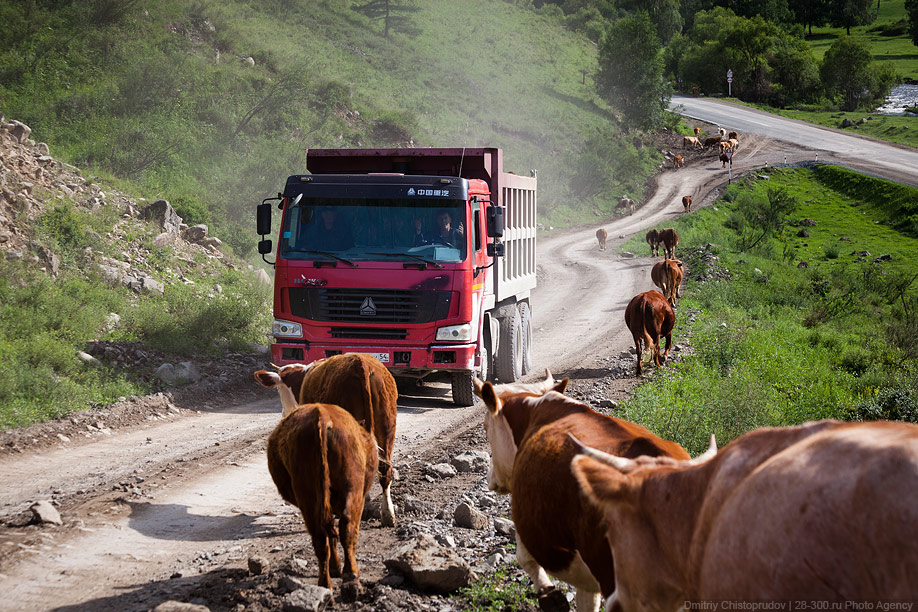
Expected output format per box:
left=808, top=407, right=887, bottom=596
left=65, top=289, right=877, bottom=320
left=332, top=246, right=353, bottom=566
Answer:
left=620, top=166, right=918, bottom=454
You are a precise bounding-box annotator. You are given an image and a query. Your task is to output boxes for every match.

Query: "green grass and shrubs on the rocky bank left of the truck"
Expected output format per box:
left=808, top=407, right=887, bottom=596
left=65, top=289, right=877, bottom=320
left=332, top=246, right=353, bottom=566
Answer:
left=0, top=194, right=271, bottom=428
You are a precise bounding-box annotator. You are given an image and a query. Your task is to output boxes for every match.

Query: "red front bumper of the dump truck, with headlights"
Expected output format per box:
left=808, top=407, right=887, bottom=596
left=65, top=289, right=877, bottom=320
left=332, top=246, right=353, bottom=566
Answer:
left=271, top=342, right=480, bottom=373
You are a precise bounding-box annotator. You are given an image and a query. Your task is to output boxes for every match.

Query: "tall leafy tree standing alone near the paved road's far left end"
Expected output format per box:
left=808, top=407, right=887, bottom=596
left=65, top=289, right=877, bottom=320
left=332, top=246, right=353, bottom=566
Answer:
left=596, top=11, right=670, bottom=130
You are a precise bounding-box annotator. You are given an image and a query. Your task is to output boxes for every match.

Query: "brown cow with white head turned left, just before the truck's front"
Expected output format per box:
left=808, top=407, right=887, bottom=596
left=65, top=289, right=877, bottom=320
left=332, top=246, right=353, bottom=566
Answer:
left=255, top=353, right=398, bottom=527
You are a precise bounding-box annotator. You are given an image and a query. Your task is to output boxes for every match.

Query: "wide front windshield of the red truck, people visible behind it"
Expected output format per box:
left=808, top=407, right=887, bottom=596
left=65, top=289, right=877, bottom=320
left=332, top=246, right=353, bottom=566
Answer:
left=280, top=198, right=469, bottom=263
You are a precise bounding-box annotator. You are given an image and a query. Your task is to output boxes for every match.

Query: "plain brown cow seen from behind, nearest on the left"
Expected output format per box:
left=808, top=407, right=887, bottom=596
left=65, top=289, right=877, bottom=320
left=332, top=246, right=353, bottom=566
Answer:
left=268, top=404, right=378, bottom=589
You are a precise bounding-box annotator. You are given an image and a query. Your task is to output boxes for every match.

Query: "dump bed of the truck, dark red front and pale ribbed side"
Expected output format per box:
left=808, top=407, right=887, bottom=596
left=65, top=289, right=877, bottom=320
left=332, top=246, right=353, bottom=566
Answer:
left=306, top=147, right=537, bottom=302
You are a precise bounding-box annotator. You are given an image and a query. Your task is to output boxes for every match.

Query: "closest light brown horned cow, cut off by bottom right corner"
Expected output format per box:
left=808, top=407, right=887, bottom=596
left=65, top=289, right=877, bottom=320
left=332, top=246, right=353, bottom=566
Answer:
left=572, top=421, right=918, bottom=611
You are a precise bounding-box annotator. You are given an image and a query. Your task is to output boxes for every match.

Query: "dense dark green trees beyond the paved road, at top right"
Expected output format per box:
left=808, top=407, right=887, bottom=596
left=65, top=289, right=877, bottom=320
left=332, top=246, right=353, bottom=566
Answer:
left=532, top=0, right=918, bottom=128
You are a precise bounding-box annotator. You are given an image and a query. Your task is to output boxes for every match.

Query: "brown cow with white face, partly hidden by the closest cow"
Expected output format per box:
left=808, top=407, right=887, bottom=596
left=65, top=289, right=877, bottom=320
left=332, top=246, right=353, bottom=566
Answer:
left=475, top=379, right=688, bottom=612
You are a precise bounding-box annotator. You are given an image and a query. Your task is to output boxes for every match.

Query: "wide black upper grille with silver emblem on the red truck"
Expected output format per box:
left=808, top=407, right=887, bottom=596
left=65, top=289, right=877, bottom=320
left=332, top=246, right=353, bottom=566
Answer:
left=288, top=287, right=450, bottom=325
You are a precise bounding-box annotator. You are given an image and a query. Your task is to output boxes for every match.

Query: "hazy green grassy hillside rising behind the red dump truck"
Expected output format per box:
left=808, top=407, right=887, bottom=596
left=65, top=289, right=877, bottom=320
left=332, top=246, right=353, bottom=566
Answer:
left=0, top=0, right=655, bottom=246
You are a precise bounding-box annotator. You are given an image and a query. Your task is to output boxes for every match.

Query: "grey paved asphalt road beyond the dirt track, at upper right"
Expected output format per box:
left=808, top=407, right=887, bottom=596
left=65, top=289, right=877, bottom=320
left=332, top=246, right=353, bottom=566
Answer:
left=670, top=96, right=918, bottom=186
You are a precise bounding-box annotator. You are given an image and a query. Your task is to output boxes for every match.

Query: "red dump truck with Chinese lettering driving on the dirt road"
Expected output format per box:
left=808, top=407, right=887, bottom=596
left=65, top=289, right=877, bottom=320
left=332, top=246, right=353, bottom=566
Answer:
left=257, top=148, right=536, bottom=406
